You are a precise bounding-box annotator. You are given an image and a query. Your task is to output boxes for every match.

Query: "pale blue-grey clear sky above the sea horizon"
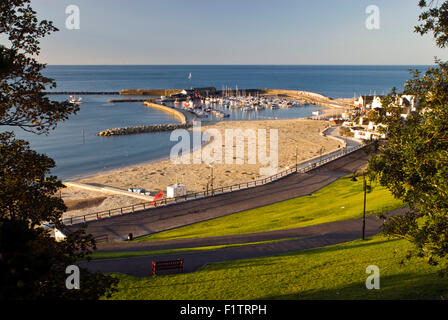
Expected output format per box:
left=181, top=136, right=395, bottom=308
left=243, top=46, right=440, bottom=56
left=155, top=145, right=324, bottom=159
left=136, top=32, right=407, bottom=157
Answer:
left=19, top=0, right=448, bottom=65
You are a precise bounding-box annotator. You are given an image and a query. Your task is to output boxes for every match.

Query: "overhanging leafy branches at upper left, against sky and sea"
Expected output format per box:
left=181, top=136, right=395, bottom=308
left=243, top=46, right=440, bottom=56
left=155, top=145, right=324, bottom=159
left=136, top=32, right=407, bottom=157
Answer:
left=0, top=0, right=78, bottom=133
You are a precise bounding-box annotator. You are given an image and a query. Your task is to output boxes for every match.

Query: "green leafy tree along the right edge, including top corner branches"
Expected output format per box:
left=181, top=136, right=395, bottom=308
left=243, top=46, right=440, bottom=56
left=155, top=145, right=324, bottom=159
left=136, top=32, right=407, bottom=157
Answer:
left=369, top=1, right=448, bottom=275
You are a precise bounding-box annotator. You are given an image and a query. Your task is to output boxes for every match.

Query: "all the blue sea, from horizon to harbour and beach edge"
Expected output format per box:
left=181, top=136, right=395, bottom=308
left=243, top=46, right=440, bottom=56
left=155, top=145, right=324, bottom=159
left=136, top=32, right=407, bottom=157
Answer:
left=3, top=65, right=430, bottom=180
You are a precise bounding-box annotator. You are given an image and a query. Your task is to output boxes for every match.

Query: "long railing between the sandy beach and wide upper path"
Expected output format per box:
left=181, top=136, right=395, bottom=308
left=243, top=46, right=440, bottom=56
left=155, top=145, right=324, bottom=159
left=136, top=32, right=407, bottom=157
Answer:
left=63, top=141, right=365, bottom=225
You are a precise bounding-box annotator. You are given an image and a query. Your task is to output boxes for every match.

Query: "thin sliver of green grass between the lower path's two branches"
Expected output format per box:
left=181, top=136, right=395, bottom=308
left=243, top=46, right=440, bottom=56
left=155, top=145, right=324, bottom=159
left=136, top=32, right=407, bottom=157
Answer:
left=86, top=237, right=303, bottom=260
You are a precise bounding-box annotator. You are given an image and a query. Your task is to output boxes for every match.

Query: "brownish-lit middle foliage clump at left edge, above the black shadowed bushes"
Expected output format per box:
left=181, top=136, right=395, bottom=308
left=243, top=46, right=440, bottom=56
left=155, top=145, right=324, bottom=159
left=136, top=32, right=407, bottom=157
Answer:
left=0, top=132, right=66, bottom=227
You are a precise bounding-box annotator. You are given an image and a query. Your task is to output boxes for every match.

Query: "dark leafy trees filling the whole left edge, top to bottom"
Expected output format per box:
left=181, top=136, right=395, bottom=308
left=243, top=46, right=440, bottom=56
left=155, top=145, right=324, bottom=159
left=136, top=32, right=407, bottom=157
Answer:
left=0, top=0, right=117, bottom=299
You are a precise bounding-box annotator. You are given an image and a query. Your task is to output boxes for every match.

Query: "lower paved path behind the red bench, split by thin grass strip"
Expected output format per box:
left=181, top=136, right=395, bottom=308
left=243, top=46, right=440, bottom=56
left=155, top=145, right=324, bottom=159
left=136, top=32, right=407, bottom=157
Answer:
left=78, top=209, right=405, bottom=277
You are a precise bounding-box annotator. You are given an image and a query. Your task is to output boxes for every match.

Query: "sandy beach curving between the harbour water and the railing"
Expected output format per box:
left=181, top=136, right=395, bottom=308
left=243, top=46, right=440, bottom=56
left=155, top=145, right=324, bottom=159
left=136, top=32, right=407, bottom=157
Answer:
left=61, top=117, right=341, bottom=217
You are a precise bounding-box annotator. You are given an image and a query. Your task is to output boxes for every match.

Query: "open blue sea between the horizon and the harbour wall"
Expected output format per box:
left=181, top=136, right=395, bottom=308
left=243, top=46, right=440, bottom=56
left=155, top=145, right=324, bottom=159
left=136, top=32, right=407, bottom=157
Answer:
left=46, top=66, right=427, bottom=98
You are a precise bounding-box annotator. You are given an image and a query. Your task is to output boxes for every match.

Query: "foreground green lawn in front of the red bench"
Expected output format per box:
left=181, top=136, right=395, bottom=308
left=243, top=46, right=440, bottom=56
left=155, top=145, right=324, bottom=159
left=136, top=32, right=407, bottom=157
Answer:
left=106, top=236, right=448, bottom=300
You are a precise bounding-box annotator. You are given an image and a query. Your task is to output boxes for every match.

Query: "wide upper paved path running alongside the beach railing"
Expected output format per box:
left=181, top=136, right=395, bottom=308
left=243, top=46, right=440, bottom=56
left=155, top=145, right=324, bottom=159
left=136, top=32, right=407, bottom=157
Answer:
left=69, top=150, right=368, bottom=241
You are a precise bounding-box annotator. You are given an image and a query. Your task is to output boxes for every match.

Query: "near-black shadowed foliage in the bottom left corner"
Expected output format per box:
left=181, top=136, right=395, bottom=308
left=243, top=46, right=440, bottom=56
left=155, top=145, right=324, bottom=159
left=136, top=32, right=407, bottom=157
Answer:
left=0, top=218, right=116, bottom=300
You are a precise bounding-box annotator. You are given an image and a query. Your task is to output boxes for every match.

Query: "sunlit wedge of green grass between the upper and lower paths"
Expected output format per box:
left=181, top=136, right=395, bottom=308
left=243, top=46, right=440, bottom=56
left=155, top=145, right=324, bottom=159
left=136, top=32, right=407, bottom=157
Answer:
left=135, top=176, right=404, bottom=241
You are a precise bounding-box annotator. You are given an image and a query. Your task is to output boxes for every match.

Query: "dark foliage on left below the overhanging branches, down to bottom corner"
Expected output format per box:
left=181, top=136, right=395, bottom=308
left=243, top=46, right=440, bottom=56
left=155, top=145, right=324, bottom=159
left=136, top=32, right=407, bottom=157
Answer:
left=0, top=132, right=116, bottom=300
